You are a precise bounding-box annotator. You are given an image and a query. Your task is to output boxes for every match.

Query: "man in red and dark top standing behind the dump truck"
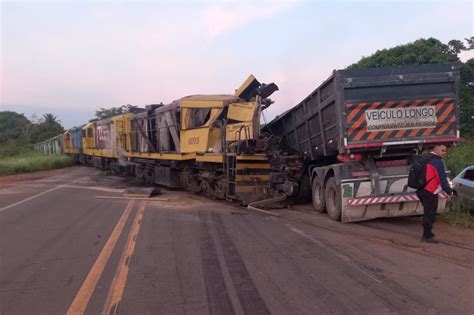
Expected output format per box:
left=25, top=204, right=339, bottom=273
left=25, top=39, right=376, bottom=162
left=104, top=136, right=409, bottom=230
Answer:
left=416, top=144, right=453, bottom=244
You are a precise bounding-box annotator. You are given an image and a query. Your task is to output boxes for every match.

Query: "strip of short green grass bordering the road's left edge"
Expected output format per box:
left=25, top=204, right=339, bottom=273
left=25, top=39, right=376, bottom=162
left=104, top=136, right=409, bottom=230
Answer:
left=0, top=152, right=74, bottom=176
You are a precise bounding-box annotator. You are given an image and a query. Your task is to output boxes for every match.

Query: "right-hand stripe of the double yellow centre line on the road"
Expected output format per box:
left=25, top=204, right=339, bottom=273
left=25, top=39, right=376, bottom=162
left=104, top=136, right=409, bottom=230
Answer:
left=102, top=201, right=146, bottom=315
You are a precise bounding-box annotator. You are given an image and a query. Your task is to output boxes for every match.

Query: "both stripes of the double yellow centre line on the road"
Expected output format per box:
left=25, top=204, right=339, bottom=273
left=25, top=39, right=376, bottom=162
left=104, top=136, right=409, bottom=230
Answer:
left=67, top=200, right=146, bottom=315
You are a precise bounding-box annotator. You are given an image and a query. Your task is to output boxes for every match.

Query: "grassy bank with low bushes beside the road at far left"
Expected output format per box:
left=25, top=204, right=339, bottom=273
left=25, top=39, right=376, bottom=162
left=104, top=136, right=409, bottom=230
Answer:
left=0, top=145, right=74, bottom=176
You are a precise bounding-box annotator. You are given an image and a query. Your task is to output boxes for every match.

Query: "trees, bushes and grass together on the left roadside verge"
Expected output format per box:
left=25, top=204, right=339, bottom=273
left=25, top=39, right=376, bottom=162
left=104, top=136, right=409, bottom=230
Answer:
left=0, top=111, right=74, bottom=176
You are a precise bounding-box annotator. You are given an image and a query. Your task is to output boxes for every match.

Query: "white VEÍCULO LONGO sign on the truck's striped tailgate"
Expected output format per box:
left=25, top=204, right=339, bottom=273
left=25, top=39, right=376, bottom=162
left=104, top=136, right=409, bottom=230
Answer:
left=365, top=106, right=437, bottom=131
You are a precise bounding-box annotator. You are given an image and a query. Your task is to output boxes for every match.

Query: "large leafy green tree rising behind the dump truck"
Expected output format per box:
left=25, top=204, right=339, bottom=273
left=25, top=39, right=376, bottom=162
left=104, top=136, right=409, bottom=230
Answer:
left=348, top=37, right=474, bottom=137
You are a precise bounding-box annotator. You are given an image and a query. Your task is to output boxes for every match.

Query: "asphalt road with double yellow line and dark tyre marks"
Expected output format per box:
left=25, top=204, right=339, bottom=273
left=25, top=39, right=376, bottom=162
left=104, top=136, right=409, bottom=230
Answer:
left=0, top=167, right=474, bottom=315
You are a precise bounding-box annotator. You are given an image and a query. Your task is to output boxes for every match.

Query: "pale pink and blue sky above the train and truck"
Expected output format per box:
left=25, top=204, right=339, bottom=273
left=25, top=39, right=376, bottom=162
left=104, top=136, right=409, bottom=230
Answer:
left=0, top=0, right=474, bottom=128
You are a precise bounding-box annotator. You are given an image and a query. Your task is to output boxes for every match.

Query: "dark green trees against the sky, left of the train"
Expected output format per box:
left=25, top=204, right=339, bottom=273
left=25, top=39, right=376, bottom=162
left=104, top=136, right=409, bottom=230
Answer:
left=0, top=111, right=65, bottom=155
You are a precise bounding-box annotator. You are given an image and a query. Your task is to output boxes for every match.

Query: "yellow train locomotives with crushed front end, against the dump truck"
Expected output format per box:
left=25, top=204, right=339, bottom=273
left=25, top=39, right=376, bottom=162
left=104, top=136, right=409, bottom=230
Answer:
left=64, top=75, right=298, bottom=205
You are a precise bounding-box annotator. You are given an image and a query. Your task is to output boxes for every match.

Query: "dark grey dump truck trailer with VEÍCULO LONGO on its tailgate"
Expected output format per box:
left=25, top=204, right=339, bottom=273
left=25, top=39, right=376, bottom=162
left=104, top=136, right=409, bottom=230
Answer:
left=264, top=64, right=460, bottom=222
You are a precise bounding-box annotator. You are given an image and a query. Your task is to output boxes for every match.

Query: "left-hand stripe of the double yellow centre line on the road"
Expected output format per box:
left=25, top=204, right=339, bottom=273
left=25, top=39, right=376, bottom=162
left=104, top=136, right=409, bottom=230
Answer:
left=67, top=200, right=135, bottom=315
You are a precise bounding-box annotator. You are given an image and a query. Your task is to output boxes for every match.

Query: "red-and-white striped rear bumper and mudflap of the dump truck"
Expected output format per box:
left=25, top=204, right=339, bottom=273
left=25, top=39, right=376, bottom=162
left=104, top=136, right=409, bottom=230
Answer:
left=341, top=193, right=448, bottom=222
